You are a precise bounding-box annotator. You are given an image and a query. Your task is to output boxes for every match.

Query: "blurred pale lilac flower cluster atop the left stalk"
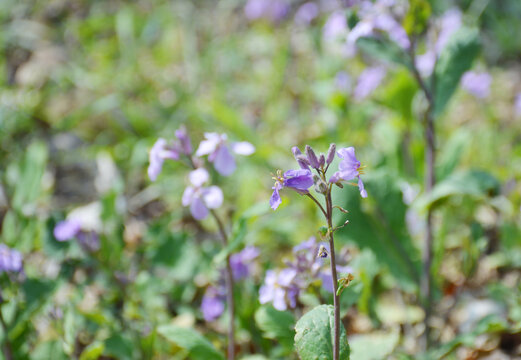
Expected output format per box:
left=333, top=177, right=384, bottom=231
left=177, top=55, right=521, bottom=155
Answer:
left=148, top=127, right=255, bottom=220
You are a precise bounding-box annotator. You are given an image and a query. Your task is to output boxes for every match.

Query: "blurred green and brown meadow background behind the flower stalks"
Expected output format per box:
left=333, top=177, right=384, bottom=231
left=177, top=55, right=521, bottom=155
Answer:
left=0, top=0, right=521, bottom=360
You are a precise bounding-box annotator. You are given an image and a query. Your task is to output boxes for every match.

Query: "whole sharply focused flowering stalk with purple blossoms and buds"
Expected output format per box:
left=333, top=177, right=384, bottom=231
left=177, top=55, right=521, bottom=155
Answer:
left=270, top=144, right=367, bottom=360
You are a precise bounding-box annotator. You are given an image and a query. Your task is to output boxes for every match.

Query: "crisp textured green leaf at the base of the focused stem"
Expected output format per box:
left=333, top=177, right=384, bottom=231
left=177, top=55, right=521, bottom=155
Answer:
left=295, top=305, right=349, bottom=360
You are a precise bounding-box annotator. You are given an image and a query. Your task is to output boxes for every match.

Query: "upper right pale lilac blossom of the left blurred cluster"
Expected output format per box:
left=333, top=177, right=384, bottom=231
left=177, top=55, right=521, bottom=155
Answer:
left=195, top=133, right=255, bottom=176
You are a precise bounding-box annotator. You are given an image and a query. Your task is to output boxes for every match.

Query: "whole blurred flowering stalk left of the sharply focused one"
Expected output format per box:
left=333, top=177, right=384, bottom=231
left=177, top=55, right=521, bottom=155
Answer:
left=148, top=127, right=255, bottom=360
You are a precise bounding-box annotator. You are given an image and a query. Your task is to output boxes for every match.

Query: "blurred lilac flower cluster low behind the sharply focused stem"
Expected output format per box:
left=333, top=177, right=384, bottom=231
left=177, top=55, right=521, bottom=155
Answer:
left=259, top=237, right=352, bottom=311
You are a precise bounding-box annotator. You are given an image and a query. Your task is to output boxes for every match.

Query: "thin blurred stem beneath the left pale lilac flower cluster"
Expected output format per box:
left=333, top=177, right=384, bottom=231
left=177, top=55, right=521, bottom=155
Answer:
left=210, top=209, right=235, bottom=360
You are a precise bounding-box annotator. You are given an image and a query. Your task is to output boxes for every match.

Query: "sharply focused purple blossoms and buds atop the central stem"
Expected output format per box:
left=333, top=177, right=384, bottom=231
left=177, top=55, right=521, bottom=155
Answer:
left=270, top=144, right=367, bottom=210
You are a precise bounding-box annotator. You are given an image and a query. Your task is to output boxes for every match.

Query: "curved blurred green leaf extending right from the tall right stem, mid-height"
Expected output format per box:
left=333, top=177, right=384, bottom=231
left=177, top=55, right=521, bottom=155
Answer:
left=414, top=170, right=499, bottom=210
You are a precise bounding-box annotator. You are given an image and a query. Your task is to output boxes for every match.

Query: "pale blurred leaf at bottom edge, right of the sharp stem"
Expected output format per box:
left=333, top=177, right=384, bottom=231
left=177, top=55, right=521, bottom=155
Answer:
left=349, top=330, right=400, bottom=360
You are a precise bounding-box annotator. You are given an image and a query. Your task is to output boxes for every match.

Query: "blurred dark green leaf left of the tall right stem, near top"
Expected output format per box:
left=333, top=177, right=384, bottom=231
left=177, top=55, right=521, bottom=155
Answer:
left=356, top=36, right=411, bottom=68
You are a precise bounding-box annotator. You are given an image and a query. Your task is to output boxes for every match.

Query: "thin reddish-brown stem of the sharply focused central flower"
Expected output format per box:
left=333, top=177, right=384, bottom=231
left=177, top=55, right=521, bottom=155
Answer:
left=326, top=193, right=340, bottom=360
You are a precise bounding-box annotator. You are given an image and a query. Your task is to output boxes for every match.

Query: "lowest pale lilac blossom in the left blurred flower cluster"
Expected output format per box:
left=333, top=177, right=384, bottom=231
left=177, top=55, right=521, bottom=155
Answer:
left=182, top=168, right=223, bottom=220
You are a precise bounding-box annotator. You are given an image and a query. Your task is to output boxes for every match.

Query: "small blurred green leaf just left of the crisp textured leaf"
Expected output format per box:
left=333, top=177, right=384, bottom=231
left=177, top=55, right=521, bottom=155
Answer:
left=255, top=306, right=295, bottom=347
